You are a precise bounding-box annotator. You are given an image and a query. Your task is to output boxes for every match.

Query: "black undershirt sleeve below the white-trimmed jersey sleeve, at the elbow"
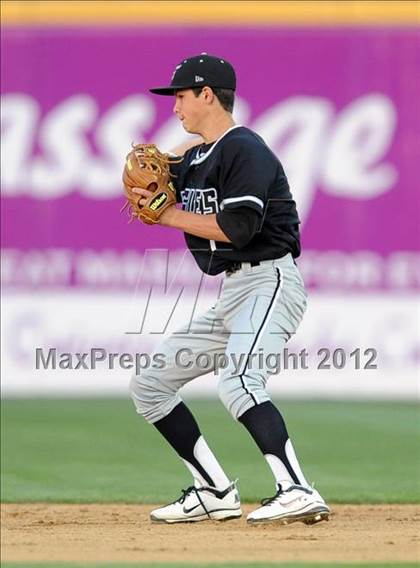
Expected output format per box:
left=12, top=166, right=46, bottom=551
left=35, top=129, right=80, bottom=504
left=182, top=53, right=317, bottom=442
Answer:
left=216, top=207, right=261, bottom=249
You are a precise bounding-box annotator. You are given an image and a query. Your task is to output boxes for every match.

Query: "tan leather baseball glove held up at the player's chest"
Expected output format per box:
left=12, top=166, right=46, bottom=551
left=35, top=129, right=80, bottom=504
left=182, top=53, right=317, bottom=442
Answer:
left=122, top=144, right=182, bottom=225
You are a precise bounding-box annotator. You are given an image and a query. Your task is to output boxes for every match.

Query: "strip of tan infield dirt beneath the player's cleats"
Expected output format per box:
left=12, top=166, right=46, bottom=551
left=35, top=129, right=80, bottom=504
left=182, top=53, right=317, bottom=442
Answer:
left=2, top=504, right=420, bottom=563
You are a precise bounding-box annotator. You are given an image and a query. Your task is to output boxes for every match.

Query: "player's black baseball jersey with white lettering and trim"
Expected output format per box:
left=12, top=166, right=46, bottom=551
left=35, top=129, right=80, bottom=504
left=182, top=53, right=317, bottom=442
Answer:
left=171, top=126, right=300, bottom=274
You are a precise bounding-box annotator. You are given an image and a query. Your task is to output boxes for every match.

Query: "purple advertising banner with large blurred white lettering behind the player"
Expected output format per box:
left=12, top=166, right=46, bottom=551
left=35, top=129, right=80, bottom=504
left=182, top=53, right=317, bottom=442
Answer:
left=1, top=27, right=420, bottom=290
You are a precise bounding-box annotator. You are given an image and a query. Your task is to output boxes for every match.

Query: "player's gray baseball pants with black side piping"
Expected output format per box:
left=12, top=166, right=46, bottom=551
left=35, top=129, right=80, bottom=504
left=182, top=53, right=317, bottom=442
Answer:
left=130, top=254, right=307, bottom=423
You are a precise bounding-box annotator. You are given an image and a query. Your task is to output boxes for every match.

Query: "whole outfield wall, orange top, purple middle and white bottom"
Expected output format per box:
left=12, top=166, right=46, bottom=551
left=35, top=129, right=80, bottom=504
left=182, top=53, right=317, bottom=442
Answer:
left=1, top=2, right=420, bottom=399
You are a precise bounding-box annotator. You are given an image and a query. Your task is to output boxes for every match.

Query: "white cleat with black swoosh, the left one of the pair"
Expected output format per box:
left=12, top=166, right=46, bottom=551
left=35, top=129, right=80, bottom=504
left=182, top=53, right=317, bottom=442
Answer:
left=150, top=483, right=242, bottom=523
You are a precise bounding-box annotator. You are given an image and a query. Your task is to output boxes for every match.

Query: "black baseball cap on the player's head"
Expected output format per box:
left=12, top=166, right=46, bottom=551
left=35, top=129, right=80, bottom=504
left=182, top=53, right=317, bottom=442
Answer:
left=149, top=53, right=236, bottom=95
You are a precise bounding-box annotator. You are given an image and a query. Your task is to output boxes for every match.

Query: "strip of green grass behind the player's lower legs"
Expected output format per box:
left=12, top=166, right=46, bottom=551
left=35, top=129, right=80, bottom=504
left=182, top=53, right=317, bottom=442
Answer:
left=1, top=400, right=420, bottom=503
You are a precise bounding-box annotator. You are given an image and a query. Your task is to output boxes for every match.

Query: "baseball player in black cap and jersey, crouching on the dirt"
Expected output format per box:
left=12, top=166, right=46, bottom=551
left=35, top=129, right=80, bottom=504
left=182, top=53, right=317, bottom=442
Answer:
left=131, top=53, right=330, bottom=524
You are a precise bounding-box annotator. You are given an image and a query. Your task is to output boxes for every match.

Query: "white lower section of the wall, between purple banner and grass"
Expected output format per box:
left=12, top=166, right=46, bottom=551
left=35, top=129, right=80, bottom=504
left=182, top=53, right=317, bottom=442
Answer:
left=2, top=291, right=420, bottom=400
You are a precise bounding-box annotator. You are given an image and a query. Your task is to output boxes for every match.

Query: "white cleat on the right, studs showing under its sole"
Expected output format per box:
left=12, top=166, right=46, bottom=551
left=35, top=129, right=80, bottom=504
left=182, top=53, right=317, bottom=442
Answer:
left=247, top=481, right=331, bottom=525
